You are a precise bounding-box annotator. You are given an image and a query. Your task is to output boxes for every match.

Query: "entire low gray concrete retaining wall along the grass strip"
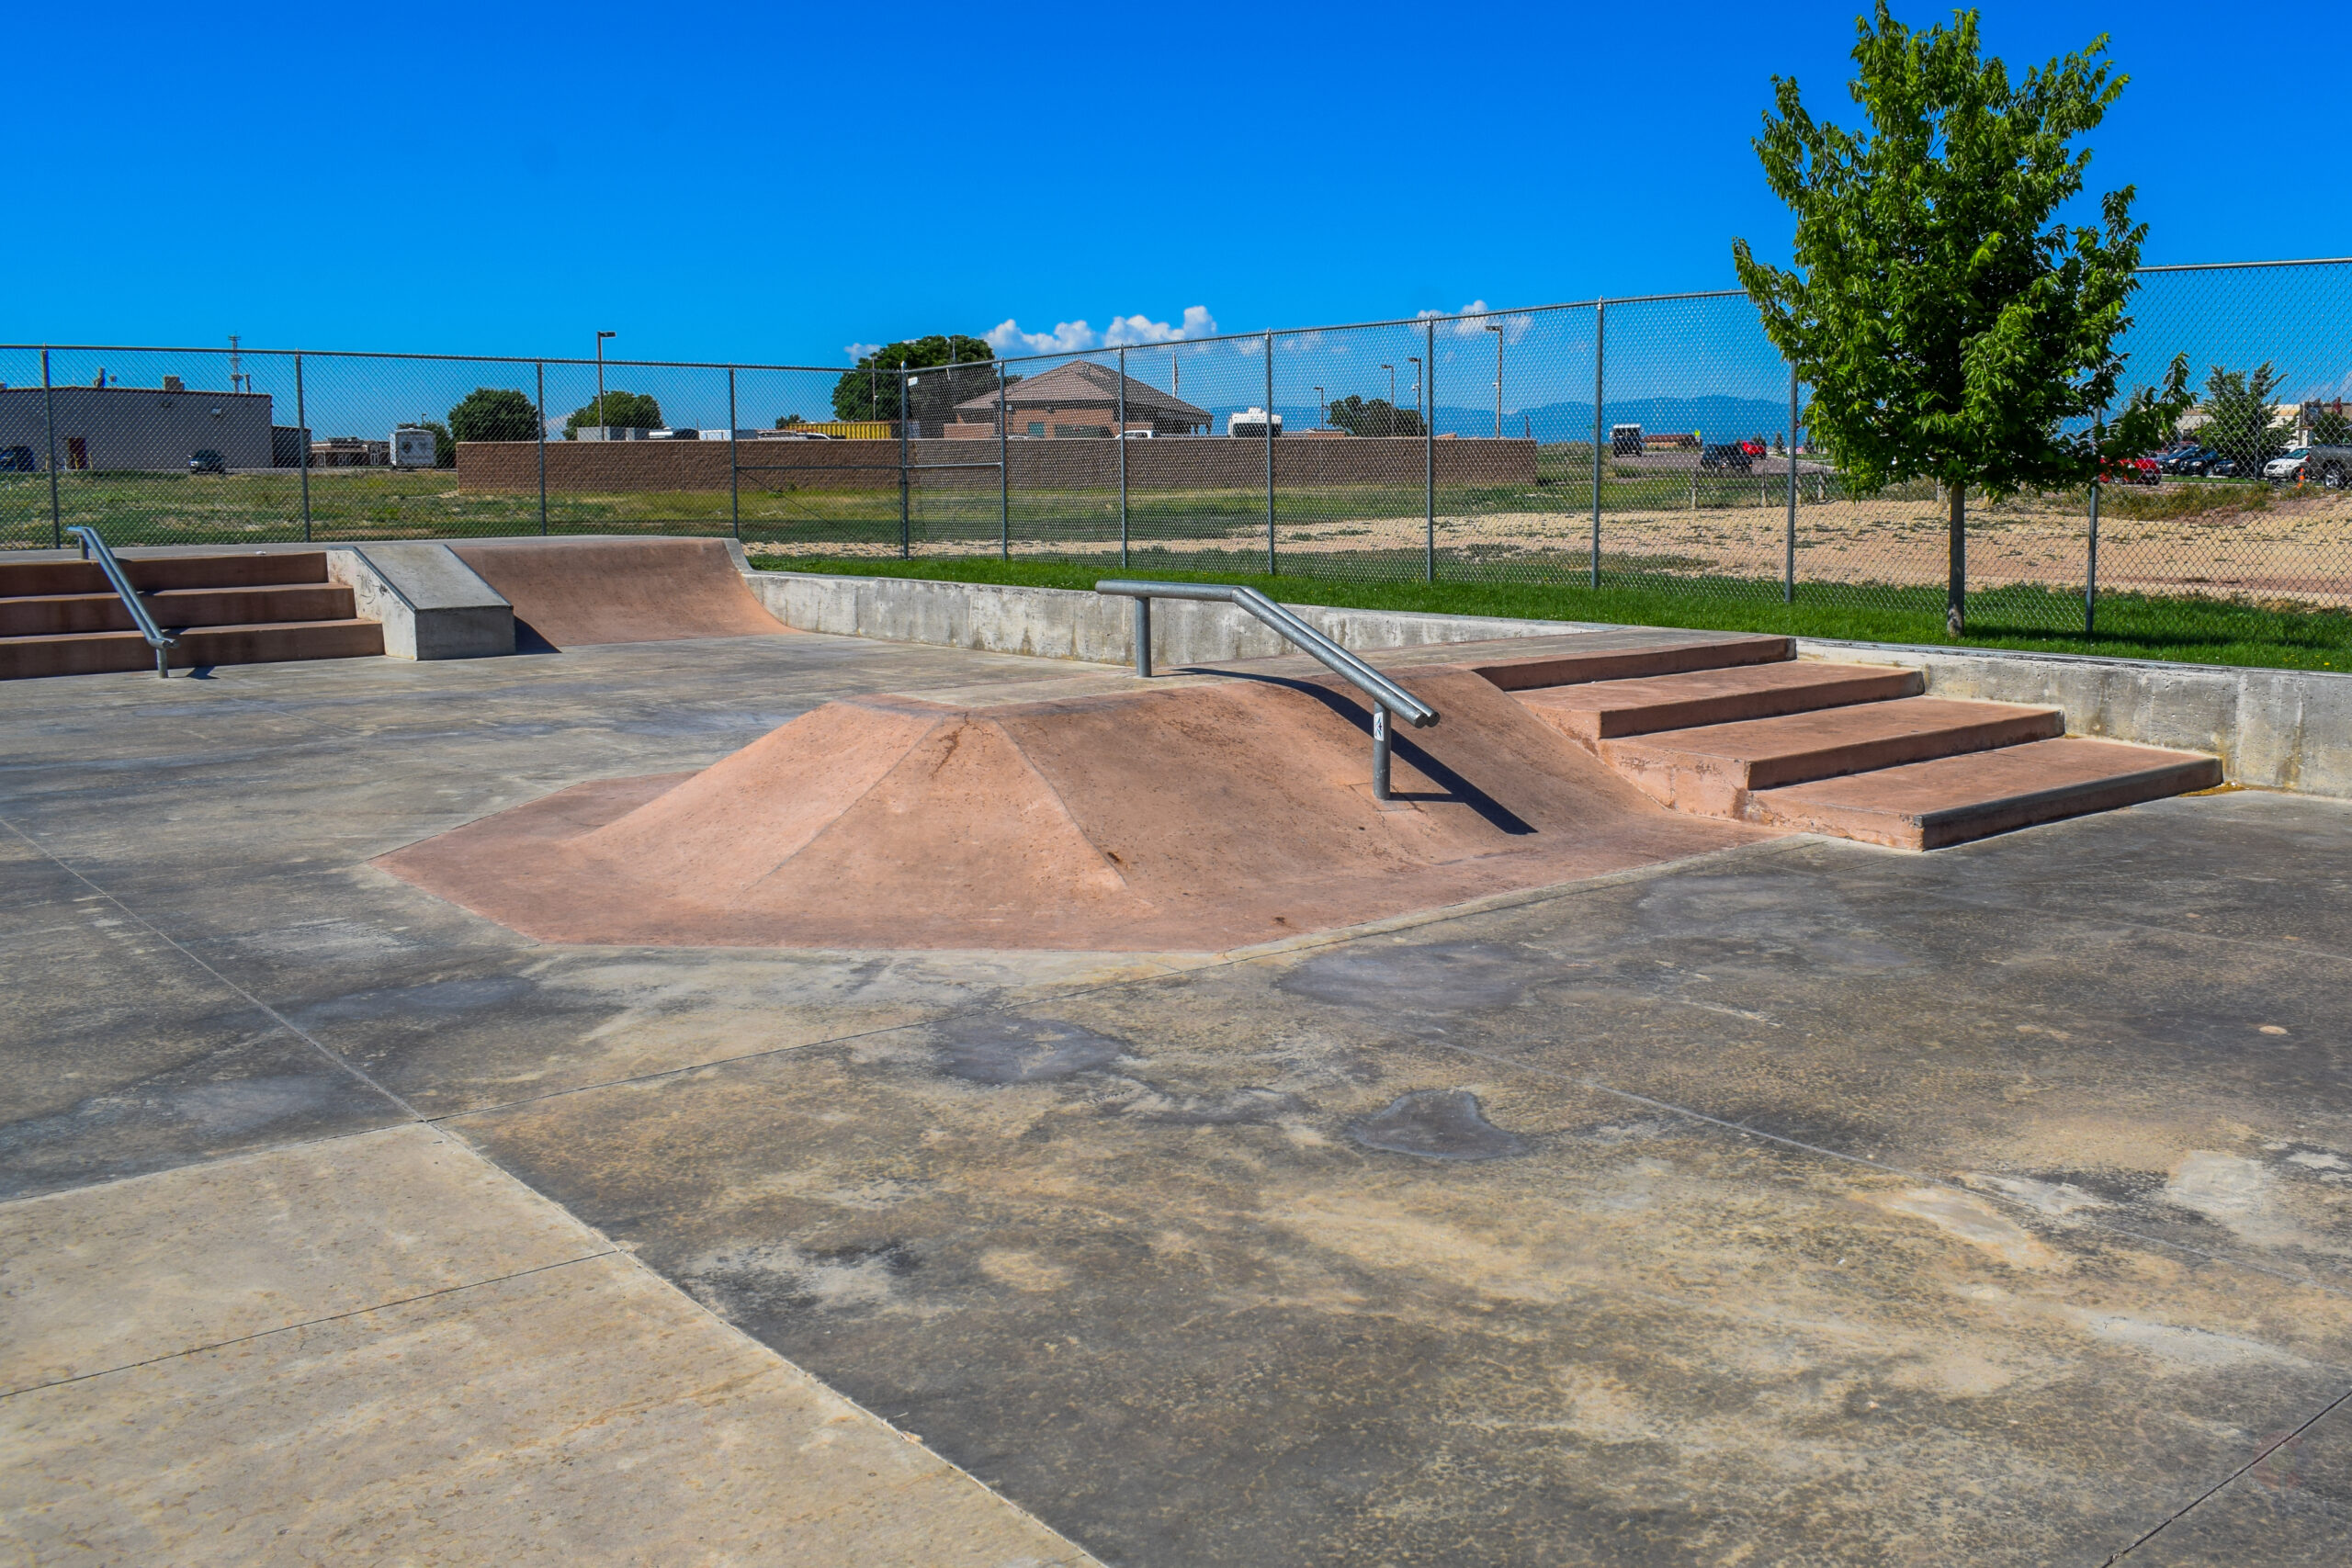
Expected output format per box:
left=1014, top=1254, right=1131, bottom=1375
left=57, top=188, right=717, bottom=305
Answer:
left=748, top=571, right=2352, bottom=799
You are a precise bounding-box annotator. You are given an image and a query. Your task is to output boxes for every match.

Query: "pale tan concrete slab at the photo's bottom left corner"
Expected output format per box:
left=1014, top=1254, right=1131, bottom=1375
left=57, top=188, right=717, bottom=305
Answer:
left=0, top=1256, right=1084, bottom=1568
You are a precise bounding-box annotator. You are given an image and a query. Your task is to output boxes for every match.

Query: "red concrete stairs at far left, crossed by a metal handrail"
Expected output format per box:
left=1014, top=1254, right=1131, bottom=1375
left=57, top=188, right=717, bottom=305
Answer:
left=0, top=550, right=383, bottom=680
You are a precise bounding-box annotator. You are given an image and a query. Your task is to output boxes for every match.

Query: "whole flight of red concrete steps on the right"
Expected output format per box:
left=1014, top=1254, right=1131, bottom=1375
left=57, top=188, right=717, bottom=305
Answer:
left=1479, top=637, right=2221, bottom=849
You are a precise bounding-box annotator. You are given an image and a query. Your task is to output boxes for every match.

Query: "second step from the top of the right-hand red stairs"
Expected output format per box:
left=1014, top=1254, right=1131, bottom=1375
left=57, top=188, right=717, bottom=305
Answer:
left=1515, top=663, right=1927, bottom=745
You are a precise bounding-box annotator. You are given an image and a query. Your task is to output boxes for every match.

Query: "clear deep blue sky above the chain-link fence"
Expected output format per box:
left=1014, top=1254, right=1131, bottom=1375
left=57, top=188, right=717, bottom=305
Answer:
left=14, top=0, right=2352, bottom=365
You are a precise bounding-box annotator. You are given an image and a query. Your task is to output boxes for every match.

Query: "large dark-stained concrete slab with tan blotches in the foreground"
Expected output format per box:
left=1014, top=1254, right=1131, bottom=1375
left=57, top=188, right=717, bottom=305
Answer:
left=458, top=1006, right=2352, bottom=1563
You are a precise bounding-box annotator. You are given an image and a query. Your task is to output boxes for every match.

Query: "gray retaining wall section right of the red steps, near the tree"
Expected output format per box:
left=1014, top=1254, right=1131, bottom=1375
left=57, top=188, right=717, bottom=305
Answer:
left=1797, top=637, right=2352, bottom=799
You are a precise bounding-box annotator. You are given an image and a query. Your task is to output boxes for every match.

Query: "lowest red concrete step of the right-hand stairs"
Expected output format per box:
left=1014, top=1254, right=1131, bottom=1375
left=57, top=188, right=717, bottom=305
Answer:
left=1746, top=736, right=2221, bottom=849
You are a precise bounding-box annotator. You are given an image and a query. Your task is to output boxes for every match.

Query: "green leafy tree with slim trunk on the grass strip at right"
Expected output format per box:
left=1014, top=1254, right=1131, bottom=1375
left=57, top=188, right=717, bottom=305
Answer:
left=1731, top=0, right=2188, bottom=637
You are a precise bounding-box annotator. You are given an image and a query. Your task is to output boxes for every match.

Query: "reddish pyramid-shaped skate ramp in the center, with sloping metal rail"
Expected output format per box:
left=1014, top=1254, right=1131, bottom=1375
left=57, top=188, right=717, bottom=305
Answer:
left=379, top=668, right=1769, bottom=952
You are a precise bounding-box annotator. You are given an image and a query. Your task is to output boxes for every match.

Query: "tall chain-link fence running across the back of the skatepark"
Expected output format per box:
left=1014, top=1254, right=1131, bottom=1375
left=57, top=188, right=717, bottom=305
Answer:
left=0, top=261, right=2352, bottom=630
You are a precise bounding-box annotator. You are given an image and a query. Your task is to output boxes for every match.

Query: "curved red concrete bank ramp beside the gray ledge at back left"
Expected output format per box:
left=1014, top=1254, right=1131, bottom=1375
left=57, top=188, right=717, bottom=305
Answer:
left=449, top=538, right=793, bottom=649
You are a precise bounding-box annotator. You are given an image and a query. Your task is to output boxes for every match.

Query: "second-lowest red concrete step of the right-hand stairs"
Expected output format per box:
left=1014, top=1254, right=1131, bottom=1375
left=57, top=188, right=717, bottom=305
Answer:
left=1595, top=696, right=2065, bottom=816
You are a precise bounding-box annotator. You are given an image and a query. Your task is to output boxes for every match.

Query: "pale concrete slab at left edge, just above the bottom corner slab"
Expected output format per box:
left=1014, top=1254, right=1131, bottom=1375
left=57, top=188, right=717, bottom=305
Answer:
left=0, top=1123, right=612, bottom=1394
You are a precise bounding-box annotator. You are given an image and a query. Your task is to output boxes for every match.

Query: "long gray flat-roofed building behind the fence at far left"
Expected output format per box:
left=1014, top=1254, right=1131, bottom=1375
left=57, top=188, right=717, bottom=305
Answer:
left=0, top=376, right=282, bottom=470
